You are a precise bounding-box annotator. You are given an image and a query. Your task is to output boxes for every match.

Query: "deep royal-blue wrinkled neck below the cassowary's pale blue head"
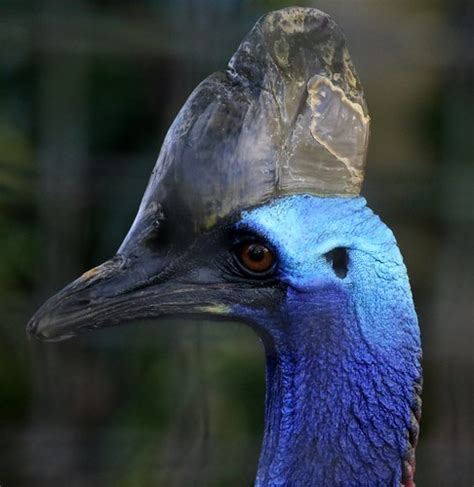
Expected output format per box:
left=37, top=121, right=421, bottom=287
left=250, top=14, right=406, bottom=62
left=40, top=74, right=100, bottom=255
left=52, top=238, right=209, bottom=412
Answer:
left=256, top=291, right=415, bottom=486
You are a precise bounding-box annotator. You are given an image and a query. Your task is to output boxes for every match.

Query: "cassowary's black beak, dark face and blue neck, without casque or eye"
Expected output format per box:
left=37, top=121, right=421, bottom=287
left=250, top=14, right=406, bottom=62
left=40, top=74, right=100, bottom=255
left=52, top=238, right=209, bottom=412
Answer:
left=29, top=195, right=421, bottom=486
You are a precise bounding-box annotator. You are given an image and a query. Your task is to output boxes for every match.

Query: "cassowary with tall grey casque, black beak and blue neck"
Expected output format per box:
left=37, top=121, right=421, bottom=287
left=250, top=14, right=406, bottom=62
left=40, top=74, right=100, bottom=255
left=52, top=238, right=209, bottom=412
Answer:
left=28, top=8, right=421, bottom=487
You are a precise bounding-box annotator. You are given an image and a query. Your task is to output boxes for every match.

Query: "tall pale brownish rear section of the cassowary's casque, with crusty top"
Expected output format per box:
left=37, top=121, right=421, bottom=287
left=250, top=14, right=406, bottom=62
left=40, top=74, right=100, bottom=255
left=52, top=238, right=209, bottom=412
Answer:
left=230, top=7, right=370, bottom=195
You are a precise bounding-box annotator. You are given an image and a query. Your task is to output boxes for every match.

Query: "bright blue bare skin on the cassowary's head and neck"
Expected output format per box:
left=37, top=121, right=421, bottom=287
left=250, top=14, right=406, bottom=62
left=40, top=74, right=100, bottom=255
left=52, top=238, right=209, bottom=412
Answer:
left=234, top=195, right=421, bottom=486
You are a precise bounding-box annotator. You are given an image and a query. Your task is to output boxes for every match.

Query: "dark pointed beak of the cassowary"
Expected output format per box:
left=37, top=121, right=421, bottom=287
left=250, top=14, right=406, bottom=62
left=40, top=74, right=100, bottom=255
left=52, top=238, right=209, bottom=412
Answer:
left=27, top=254, right=217, bottom=341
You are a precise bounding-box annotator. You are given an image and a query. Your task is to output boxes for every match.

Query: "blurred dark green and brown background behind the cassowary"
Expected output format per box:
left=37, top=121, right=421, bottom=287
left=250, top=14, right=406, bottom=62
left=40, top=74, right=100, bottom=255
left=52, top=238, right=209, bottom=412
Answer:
left=0, top=0, right=474, bottom=487
